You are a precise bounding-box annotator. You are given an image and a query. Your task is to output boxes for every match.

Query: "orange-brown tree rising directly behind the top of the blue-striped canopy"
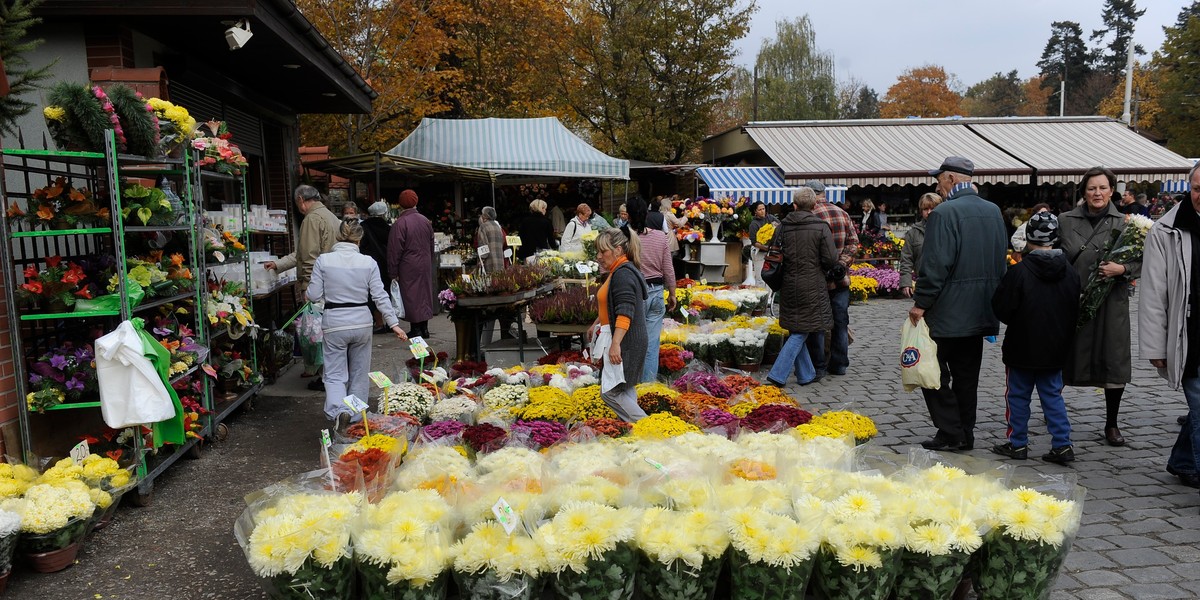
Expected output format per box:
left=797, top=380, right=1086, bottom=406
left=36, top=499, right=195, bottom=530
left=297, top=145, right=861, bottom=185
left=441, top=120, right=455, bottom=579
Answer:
left=448, top=0, right=577, bottom=118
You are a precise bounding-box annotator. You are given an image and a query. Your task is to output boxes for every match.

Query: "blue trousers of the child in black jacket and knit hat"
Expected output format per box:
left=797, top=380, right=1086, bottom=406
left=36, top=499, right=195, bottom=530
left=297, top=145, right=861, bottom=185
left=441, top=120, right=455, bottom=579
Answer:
left=1004, top=367, right=1070, bottom=448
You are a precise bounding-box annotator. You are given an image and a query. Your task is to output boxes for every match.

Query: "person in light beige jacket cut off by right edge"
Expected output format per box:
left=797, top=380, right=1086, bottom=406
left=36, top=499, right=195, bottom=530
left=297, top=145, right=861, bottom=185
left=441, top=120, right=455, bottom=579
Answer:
left=1138, top=166, right=1200, bottom=487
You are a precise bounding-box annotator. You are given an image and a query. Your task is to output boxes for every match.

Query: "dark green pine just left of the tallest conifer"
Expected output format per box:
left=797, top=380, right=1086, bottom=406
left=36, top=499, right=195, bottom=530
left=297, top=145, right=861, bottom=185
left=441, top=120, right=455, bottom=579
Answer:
left=1038, top=20, right=1099, bottom=115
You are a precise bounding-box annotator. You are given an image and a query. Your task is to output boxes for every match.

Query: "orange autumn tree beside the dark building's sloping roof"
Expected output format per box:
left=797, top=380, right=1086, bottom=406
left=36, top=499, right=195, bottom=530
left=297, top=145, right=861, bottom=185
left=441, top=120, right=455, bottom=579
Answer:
left=296, top=0, right=467, bottom=154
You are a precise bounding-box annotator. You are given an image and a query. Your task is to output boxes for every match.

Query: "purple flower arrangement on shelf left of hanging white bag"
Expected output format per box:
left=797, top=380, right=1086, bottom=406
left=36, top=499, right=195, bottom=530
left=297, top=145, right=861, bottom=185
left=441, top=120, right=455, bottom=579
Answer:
left=25, top=342, right=98, bottom=413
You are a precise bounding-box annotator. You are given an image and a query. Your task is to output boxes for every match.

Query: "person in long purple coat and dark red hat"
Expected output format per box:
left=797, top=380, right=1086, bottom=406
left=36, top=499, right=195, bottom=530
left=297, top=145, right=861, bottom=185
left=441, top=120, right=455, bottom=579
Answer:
left=388, top=190, right=433, bottom=337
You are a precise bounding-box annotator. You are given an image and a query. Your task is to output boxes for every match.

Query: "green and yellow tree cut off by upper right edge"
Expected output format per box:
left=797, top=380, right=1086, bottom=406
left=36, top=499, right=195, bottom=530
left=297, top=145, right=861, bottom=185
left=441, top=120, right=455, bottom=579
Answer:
left=1157, top=10, right=1200, bottom=156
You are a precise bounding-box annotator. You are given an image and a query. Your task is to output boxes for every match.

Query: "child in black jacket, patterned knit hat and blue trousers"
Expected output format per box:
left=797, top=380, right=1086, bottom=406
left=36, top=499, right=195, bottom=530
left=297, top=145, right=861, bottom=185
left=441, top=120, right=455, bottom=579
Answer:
left=991, top=211, right=1081, bottom=463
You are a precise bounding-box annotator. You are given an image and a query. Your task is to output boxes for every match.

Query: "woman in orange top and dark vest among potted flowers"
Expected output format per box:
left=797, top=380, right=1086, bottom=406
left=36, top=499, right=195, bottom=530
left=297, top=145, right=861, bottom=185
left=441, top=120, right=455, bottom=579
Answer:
left=592, top=226, right=649, bottom=422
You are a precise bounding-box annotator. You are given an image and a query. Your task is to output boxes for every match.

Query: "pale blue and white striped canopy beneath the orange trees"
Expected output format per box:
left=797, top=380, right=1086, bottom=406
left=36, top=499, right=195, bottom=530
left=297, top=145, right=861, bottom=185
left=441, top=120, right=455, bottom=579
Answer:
left=386, top=116, right=629, bottom=179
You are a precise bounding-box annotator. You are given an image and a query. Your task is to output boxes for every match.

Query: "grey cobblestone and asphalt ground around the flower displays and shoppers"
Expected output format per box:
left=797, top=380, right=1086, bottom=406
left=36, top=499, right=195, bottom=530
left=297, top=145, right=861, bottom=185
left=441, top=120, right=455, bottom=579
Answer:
left=7, top=300, right=1200, bottom=600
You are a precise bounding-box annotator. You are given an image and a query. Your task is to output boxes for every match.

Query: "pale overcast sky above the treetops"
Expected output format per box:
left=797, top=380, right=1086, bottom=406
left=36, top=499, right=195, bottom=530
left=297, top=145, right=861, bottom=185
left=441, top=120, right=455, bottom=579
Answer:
left=738, top=0, right=1192, bottom=92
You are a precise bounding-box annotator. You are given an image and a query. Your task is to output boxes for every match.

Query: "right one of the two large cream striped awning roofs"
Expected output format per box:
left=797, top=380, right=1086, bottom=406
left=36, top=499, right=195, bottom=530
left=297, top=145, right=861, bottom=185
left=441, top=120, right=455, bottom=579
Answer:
left=964, top=118, right=1192, bottom=184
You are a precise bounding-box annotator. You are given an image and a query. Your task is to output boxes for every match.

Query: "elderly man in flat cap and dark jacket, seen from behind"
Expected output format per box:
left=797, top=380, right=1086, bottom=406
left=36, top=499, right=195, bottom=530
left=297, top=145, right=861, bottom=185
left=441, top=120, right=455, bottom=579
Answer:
left=908, top=156, right=1008, bottom=450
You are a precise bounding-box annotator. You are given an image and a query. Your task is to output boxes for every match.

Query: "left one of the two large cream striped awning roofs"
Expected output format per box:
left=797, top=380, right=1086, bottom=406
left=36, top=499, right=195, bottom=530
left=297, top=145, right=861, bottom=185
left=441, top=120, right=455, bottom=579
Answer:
left=746, top=120, right=1033, bottom=186
